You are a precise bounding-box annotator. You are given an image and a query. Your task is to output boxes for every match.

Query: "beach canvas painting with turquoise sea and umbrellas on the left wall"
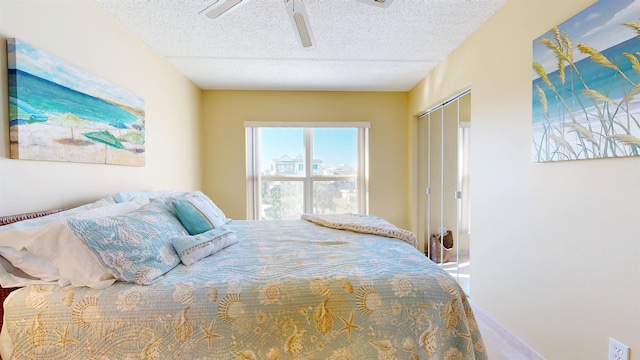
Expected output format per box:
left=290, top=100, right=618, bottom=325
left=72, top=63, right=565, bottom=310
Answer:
left=7, top=39, right=145, bottom=166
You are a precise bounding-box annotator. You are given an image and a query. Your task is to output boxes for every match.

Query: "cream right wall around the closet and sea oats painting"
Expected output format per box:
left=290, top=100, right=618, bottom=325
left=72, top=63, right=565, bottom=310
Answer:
left=410, top=0, right=640, bottom=360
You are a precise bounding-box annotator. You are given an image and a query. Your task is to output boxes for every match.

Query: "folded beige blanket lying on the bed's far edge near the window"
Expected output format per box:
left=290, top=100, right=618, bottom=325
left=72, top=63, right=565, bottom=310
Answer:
left=301, top=214, right=418, bottom=249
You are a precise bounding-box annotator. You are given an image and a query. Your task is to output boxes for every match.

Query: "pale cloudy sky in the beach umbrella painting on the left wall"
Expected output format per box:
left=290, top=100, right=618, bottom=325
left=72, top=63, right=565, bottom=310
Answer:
left=7, top=39, right=144, bottom=110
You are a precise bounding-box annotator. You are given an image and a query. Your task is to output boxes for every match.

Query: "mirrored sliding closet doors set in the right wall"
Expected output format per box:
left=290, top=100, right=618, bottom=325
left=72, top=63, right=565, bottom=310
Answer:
left=417, top=92, right=471, bottom=294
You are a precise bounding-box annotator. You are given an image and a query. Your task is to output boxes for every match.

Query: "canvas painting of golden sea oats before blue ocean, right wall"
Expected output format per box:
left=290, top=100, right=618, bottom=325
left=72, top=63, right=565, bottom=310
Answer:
left=532, top=0, right=640, bottom=162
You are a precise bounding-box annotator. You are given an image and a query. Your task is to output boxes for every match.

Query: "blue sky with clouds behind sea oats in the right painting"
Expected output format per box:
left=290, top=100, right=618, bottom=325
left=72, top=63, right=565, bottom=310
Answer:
left=533, top=0, right=640, bottom=74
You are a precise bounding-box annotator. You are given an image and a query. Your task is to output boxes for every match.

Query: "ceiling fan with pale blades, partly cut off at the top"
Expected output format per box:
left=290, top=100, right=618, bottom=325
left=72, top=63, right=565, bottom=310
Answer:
left=199, top=0, right=393, bottom=49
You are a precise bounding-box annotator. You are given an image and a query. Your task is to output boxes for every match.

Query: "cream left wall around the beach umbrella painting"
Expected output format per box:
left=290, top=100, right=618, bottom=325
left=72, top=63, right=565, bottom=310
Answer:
left=0, top=0, right=201, bottom=215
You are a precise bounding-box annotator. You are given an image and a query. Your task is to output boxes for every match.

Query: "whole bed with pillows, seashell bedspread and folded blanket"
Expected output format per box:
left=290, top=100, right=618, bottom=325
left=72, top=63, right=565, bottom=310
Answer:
left=0, top=192, right=486, bottom=360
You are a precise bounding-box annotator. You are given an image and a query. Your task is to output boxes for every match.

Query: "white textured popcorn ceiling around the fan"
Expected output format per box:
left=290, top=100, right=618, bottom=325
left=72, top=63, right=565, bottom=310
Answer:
left=96, top=0, right=507, bottom=91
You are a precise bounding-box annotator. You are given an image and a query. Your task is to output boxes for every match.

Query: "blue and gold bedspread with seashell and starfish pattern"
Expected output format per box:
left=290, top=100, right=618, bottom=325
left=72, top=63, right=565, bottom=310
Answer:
left=2, top=220, right=486, bottom=360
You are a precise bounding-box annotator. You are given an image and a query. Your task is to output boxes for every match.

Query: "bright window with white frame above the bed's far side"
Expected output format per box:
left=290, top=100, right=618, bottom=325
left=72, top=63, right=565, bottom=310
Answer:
left=245, top=122, right=369, bottom=220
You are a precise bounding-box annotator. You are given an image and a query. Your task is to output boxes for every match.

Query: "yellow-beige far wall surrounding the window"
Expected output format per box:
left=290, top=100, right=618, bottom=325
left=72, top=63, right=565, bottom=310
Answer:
left=202, top=91, right=409, bottom=227
